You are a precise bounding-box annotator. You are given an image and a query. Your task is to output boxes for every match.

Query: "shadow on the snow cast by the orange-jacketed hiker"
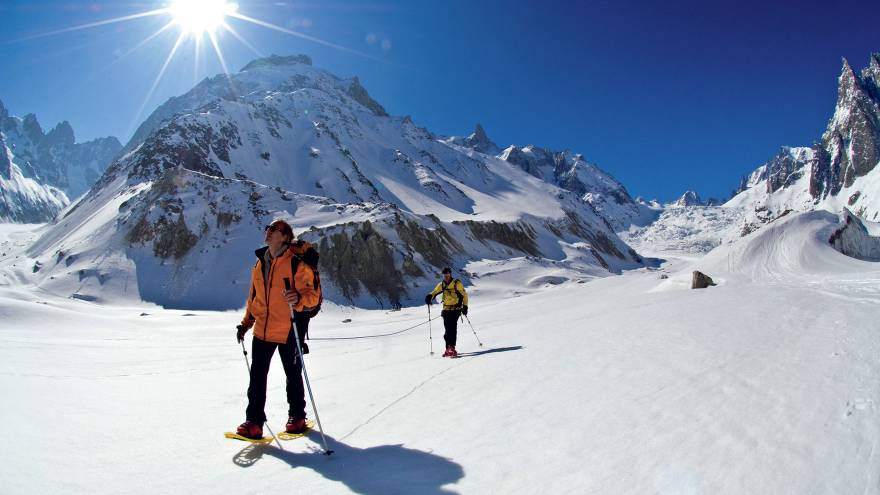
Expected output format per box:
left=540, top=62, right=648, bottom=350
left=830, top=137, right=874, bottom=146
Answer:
left=232, top=431, right=464, bottom=495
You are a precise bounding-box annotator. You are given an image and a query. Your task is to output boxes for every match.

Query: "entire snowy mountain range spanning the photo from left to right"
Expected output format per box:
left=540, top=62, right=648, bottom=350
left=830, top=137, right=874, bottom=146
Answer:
left=8, top=50, right=880, bottom=309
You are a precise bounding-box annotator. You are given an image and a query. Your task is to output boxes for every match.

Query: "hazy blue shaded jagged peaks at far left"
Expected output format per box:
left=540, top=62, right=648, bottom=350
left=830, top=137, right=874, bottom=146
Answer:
left=0, top=98, right=122, bottom=198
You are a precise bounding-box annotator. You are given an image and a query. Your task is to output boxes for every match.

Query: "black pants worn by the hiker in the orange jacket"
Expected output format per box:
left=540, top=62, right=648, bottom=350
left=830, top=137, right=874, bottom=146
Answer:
left=245, top=314, right=309, bottom=424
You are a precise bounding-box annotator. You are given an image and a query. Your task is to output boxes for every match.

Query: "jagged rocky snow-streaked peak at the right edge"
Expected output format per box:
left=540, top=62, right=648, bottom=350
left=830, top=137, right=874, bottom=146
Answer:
left=726, top=53, right=880, bottom=221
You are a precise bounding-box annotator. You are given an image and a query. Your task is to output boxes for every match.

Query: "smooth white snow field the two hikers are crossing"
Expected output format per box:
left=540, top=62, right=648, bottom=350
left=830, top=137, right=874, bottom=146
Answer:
left=0, top=212, right=880, bottom=494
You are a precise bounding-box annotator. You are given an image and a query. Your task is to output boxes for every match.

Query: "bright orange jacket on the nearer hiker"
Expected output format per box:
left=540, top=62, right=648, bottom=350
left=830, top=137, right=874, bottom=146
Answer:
left=241, top=246, right=318, bottom=344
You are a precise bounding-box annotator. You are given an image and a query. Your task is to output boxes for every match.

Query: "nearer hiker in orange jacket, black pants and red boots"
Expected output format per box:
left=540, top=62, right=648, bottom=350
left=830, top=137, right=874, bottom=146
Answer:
left=236, top=220, right=320, bottom=438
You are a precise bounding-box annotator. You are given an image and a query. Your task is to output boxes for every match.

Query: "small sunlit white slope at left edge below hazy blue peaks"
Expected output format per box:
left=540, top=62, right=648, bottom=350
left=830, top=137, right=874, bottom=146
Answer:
left=0, top=132, right=69, bottom=223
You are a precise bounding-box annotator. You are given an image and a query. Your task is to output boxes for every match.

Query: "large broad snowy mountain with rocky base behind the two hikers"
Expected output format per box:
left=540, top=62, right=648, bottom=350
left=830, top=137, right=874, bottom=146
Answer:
left=30, top=55, right=641, bottom=308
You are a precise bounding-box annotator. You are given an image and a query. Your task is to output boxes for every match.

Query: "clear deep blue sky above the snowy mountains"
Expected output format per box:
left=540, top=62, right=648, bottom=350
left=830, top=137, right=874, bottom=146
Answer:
left=0, top=0, right=880, bottom=201
